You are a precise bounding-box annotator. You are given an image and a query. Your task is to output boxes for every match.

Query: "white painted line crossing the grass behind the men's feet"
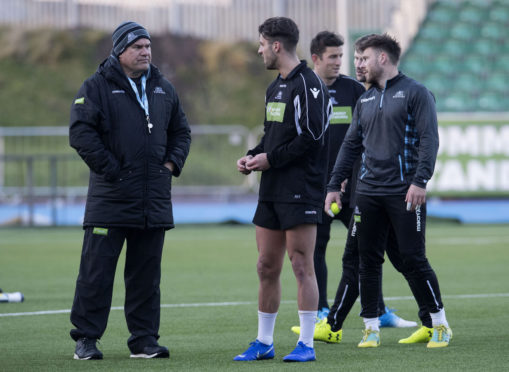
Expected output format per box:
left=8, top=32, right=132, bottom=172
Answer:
left=0, top=293, right=509, bottom=317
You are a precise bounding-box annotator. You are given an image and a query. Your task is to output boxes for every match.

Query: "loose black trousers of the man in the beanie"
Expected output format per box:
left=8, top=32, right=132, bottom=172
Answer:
left=70, top=227, right=165, bottom=351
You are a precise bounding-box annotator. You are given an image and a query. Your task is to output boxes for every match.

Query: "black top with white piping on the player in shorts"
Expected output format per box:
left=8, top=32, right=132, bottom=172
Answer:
left=247, top=61, right=332, bottom=207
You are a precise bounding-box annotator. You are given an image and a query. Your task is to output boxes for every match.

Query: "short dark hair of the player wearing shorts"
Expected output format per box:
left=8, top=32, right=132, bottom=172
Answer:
left=258, top=17, right=299, bottom=52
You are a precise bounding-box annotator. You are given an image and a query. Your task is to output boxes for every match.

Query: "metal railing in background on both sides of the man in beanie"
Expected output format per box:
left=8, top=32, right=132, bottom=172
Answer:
left=0, top=125, right=261, bottom=226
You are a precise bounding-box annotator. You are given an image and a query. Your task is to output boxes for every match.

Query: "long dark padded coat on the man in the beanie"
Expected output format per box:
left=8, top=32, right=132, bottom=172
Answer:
left=69, top=56, right=191, bottom=229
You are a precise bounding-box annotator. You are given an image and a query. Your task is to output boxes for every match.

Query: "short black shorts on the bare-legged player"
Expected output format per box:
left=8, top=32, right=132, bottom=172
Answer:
left=253, top=201, right=323, bottom=230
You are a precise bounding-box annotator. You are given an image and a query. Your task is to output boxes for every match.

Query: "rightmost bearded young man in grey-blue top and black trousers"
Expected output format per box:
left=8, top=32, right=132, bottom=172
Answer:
left=324, top=34, right=452, bottom=348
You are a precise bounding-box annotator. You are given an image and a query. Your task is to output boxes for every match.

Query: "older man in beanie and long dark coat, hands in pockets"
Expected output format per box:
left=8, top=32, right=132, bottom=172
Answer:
left=69, top=22, right=191, bottom=359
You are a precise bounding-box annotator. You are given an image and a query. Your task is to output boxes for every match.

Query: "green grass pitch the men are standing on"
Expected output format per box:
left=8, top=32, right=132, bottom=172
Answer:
left=0, top=221, right=509, bottom=372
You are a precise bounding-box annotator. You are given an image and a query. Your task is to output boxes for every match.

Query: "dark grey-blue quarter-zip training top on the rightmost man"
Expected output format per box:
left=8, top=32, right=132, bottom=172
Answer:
left=327, top=72, right=438, bottom=195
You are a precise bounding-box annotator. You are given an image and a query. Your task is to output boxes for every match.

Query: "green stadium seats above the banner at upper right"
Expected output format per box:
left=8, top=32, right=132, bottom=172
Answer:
left=400, top=0, right=509, bottom=112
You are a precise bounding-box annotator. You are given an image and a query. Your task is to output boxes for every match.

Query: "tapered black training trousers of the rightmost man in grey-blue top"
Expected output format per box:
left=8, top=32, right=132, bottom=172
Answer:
left=354, top=194, right=443, bottom=320
